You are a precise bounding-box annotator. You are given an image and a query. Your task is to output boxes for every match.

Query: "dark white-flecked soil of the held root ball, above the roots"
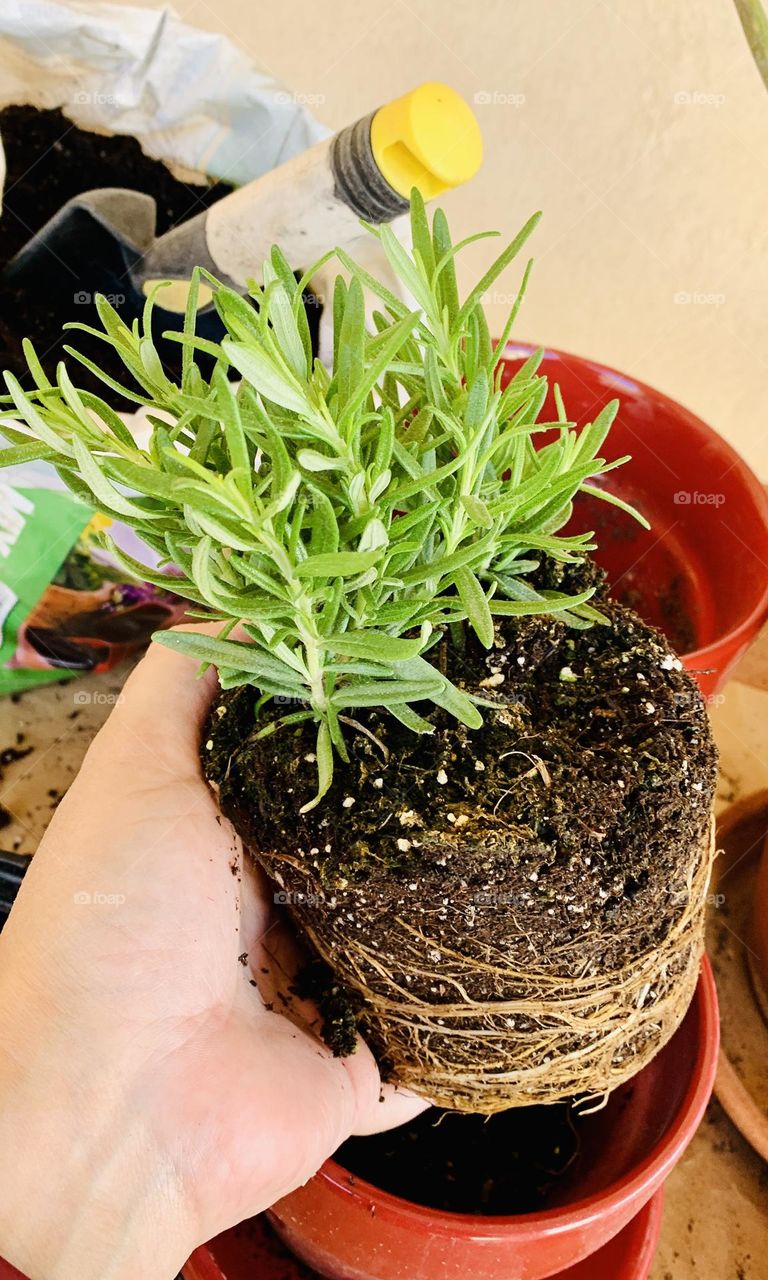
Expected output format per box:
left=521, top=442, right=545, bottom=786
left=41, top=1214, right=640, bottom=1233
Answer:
left=202, top=581, right=717, bottom=1069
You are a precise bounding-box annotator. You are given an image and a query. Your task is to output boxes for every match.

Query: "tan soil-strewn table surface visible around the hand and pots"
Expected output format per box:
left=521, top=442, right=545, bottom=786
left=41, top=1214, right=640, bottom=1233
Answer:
left=0, top=666, right=768, bottom=1280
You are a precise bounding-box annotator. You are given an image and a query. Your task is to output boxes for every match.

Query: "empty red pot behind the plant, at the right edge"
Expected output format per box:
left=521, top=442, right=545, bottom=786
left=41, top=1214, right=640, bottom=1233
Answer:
left=506, top=343, right=768, bottom=695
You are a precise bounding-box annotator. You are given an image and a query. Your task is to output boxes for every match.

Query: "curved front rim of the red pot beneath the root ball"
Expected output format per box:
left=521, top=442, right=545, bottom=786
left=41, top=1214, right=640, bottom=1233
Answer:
left=313, top=955, right=719, bottom=1242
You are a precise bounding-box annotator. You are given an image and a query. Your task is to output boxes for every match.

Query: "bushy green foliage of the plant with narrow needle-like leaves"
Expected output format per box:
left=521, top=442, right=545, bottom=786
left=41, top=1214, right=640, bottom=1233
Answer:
left=1, top=192, right=645, bottom=803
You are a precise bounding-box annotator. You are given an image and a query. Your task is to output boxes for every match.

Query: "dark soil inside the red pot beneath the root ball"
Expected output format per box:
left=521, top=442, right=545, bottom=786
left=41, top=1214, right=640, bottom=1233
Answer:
left=334, top=1103, right=584, bottom=1216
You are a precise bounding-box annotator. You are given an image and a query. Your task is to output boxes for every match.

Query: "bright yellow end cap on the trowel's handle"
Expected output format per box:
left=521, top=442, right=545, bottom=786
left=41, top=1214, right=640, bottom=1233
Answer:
left=371, top=81, right=483, bottom=200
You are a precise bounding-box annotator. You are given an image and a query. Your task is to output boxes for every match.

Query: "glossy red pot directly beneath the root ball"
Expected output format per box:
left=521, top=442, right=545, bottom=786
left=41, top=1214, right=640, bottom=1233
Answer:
left=186, top=960, right=719, bottom=1280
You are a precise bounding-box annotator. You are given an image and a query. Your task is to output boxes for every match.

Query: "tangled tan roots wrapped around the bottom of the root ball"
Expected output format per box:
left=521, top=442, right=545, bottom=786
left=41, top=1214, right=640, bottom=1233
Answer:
left=262, top=824, right=714, bottom=1115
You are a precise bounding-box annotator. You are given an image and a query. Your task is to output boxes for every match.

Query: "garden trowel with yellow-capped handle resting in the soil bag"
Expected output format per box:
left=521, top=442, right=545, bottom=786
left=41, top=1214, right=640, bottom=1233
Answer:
left=4, top=82, right=483, bottom=314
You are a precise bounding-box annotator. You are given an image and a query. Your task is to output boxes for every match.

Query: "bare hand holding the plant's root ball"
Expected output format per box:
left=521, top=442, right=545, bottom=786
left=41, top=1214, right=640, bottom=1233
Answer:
left=0, top=646, right=422, bottom=1280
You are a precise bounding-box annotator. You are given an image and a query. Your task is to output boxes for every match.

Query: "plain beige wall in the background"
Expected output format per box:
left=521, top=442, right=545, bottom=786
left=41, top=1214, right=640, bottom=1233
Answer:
left=121, top=0, right=768, bottom=480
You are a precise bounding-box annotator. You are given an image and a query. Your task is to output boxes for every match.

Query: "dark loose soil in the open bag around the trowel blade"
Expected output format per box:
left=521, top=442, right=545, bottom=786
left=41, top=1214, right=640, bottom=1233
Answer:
left=0, top=106, right=321, bottom=408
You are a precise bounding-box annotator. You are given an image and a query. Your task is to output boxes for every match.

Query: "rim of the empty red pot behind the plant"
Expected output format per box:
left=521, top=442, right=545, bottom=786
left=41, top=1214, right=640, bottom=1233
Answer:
left=500, top=339, right=768, bottom=668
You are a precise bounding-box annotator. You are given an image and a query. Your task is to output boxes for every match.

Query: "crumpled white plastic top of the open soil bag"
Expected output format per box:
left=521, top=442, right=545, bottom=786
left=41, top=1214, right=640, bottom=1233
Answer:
left=0, top=0, right=329, bottom=186
